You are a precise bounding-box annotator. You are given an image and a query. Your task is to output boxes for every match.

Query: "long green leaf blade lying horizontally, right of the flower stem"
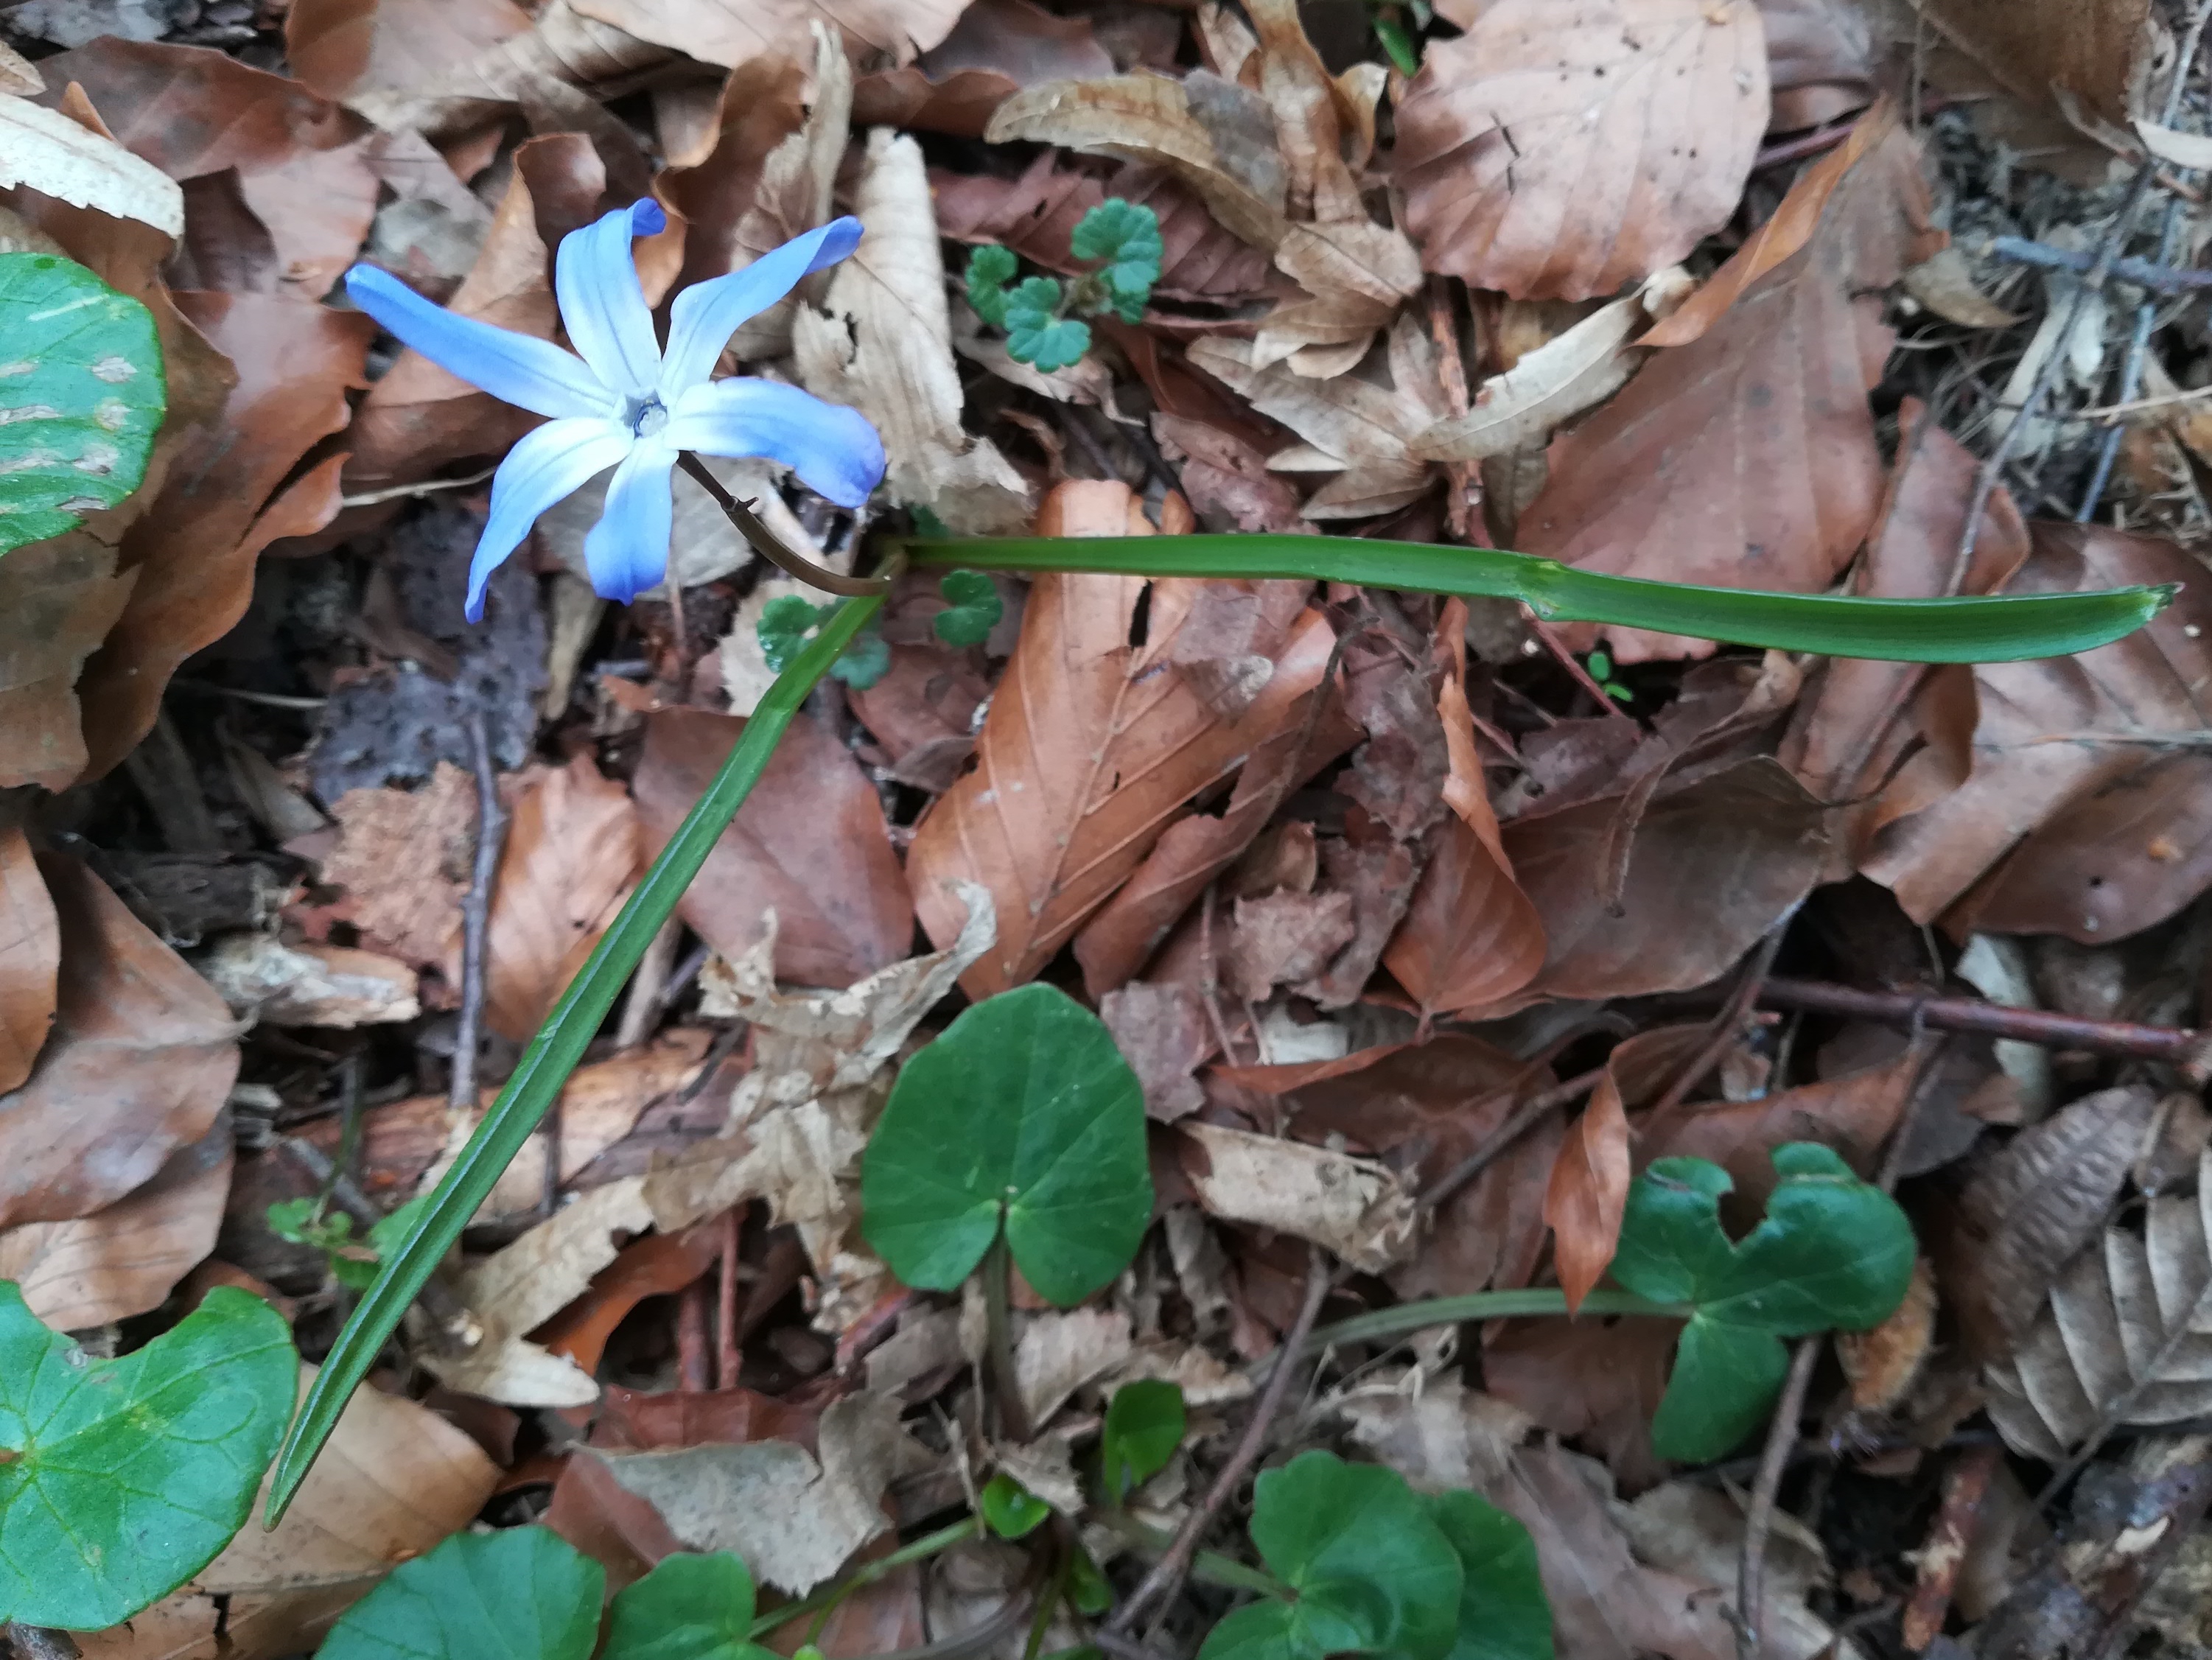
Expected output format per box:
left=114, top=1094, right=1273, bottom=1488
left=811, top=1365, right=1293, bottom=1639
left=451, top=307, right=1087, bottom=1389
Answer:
left=900, top=536, right=2174, bottom=662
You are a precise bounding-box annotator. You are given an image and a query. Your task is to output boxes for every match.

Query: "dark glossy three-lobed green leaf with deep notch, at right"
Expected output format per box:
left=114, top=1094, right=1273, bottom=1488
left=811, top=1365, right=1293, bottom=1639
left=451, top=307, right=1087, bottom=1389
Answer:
left=1612, top=1142, right=1916, bottom=1463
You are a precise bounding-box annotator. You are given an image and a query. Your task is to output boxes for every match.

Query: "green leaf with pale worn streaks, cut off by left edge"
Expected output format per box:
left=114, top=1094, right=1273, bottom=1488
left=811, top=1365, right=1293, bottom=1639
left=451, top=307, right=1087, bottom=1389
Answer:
left=0, top=254, right=168, bottom=553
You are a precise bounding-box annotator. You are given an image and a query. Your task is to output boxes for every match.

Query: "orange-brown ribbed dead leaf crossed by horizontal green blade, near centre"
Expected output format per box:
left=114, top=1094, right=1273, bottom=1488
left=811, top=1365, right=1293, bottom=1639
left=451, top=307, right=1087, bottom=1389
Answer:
left=907, top=480, right=1331, bottom=996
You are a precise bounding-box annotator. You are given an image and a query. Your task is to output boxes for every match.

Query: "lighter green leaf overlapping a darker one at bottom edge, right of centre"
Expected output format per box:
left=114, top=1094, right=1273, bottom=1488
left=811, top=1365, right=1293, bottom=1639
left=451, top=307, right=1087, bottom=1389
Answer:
left=1199, top=1452, right=1466, bottom=1660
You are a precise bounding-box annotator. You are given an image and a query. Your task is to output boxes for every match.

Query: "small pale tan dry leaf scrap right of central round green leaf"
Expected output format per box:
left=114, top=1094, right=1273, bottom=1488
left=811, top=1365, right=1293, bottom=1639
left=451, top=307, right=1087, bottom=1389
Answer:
left=1181, top=1120, right=1418, bottom=1272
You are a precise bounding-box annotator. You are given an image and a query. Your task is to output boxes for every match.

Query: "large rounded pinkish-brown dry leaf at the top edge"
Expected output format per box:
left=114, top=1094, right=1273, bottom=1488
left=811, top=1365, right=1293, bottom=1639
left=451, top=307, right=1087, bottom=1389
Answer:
left=1396, top=0, right=1768, bottom=299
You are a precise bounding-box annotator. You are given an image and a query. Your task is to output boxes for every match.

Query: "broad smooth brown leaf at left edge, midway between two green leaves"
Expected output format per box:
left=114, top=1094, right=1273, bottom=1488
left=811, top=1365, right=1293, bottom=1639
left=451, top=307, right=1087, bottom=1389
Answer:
left=0, top=855, right=239, bottom=1226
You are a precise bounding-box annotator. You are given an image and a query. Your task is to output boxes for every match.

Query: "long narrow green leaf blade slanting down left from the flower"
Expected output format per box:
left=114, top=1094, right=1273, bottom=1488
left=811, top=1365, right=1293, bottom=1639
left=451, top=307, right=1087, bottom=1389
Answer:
left=265, top=598, right=883, bottom=1527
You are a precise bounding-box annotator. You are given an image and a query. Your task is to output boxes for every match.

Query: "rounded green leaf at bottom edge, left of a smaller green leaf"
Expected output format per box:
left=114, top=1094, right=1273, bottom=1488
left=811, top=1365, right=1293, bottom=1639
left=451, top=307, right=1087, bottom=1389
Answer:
left=316, top=1527, right=606, bottom=1660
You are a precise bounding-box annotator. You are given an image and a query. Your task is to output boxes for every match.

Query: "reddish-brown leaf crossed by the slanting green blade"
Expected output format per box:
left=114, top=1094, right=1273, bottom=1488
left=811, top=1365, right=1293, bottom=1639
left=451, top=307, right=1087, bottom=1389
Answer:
left=631, top=708, right=911, bottom=985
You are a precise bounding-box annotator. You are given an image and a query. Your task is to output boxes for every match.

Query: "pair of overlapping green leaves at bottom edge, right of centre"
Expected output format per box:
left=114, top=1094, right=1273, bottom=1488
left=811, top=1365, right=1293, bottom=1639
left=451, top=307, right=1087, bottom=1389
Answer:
left=1199, top=1452, right=1553, bottom=1660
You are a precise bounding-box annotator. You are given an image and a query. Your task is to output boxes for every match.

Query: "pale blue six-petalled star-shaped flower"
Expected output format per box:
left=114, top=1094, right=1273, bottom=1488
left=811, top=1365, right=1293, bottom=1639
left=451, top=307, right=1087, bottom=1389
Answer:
left=345, top=201, right=883, bottom=622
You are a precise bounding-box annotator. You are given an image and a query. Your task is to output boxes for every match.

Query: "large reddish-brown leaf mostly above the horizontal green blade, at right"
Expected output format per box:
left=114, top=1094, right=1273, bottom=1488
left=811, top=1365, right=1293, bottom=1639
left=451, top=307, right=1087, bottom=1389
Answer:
left=1517, top=100, right=1940, bottom=662
